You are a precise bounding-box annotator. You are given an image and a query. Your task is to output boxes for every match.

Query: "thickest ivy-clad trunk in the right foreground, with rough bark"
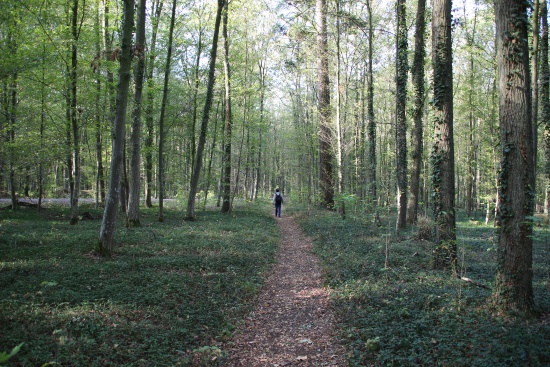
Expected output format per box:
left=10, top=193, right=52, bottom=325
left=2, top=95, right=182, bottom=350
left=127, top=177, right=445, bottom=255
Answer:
left=493, top=0, right=535, bottom=315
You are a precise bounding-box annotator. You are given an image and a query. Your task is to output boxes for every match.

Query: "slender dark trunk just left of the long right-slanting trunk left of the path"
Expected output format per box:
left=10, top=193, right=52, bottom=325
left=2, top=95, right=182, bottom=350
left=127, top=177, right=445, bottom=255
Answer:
left=158, top=0, right=177, bottom=222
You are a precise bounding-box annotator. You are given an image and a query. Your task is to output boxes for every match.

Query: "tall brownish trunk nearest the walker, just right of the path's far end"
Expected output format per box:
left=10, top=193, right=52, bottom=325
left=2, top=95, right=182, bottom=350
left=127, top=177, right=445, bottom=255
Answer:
left=315, top=0, right=334, bottom=209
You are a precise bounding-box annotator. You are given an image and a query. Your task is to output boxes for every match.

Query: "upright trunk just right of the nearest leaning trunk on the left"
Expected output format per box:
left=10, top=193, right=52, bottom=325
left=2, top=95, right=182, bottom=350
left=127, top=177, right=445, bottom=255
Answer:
left=127, top=0, right=146, bottom=227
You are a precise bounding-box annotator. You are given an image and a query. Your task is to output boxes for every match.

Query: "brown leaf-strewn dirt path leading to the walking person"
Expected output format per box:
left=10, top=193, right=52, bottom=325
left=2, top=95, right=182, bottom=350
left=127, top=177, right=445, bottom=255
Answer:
left=226, top=217, right=345, bottom=367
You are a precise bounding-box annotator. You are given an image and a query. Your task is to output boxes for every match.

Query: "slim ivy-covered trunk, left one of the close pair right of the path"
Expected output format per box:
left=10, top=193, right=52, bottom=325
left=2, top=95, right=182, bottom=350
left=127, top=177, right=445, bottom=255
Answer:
left=395, top=0, right=409, bottom=230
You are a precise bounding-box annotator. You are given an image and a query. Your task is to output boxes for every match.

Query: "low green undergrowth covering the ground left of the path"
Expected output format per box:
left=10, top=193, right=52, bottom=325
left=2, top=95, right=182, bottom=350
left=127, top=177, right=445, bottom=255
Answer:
left=0, top=204, right=279, bottom=366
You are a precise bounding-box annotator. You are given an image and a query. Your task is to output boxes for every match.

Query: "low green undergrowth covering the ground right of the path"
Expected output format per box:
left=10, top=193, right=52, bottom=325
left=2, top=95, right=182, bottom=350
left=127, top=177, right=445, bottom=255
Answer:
left=298, top=211, right=550, bottom=367
